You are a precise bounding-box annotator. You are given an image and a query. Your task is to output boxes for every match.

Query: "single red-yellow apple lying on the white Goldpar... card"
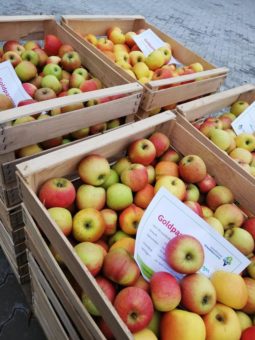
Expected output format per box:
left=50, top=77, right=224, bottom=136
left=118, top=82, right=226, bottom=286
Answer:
left=165, top=235, right=204, bottom=274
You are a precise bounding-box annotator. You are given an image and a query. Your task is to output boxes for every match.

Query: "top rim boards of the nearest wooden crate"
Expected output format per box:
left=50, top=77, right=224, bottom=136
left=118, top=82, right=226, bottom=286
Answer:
left=17, top=111, right=255, bottom=339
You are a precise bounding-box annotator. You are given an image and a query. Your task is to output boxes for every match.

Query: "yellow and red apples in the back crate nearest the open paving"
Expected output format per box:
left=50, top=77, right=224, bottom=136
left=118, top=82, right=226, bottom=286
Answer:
left=77, top=26, right=203, bottom=84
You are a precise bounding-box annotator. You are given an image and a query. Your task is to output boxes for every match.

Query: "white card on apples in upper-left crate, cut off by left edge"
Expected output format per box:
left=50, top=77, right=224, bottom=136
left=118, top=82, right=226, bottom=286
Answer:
left=0, top=60, right=32, bottom=106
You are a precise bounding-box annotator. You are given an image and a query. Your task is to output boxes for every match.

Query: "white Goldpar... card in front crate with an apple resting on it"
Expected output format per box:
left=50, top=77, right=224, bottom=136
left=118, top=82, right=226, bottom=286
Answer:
left=134, top=188, right=250, bottom=280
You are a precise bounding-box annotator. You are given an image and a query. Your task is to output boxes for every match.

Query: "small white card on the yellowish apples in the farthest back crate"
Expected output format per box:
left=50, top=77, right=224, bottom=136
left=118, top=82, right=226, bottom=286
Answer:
left=133, top=29, right=166, bottom=57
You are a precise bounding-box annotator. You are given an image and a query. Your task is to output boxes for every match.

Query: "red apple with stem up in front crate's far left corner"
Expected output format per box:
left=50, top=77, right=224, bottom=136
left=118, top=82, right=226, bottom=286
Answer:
left=38, top=177, right=76, bottom=208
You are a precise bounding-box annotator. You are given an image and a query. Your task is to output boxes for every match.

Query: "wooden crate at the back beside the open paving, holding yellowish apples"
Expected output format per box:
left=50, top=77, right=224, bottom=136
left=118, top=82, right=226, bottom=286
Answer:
left=61, top=15, right=228, bottom=111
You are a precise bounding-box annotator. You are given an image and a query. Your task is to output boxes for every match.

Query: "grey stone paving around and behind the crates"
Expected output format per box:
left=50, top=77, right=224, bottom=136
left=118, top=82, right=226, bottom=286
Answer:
left=0, top=0, right=255, bottom=340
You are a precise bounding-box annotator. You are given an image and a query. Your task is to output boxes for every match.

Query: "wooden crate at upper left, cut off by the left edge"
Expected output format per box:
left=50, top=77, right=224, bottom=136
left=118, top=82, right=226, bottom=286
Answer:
left=0, top=16, right=143, bottom=207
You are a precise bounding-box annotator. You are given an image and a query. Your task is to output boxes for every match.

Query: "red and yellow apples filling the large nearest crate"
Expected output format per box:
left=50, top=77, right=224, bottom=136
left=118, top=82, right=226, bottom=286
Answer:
left=38, top=132, right=255, bottom=340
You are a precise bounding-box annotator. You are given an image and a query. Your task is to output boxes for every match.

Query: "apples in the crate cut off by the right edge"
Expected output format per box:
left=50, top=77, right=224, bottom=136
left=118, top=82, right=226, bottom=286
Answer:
left=195, top=100, right=255, bottom=176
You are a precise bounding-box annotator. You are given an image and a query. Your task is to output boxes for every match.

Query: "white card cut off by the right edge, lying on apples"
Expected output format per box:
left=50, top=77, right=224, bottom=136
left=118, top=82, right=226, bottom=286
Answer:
left=231, top=101, right=255, bottom=135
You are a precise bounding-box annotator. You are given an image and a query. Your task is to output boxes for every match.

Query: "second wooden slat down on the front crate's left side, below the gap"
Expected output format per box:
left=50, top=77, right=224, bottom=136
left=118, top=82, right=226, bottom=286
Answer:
left=22, top=203, right=105, bottom=340
